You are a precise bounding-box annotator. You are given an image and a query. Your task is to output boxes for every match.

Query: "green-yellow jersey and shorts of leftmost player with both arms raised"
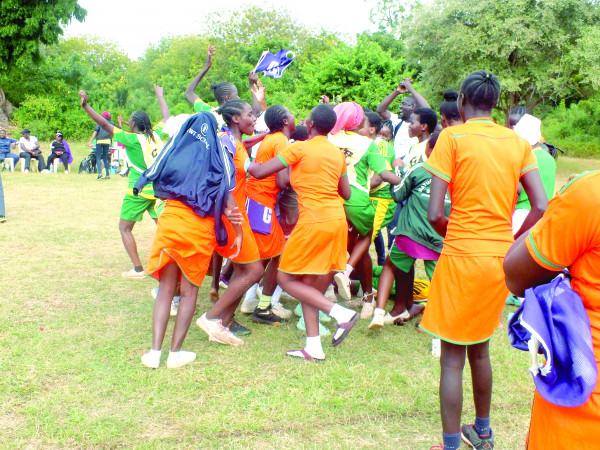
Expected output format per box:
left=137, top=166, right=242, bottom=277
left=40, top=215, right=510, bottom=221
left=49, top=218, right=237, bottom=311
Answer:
left=113, top=122, right=164, bottom=222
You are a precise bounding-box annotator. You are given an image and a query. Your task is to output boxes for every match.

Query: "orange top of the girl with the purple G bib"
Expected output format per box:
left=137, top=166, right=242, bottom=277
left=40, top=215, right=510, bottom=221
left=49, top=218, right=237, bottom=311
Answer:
left=246, top=131, right=288, bottom=209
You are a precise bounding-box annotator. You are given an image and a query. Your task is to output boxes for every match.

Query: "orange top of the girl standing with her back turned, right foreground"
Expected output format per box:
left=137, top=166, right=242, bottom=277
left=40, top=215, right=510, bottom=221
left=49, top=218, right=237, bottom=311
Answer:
left=423, top=118, right=537, bottom=257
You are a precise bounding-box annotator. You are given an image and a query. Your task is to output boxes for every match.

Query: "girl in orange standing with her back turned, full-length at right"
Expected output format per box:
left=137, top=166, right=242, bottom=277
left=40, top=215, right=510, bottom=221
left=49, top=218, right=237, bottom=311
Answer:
left=420, top=71, right=547, bottom=450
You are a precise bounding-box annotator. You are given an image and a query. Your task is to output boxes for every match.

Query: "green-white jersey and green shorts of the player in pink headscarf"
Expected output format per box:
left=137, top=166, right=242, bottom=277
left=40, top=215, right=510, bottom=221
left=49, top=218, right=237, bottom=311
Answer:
left=329, top=130, right=391, bottom=236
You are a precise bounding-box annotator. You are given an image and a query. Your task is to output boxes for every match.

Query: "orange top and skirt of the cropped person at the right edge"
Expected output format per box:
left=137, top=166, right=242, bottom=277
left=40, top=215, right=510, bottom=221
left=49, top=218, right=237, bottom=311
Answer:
left=524, top=171, right=600, bottom=450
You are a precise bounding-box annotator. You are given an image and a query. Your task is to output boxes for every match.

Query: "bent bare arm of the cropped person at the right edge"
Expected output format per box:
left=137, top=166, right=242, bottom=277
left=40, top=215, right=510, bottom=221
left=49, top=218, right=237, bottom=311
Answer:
left=504, top=233, right=558, bottom=297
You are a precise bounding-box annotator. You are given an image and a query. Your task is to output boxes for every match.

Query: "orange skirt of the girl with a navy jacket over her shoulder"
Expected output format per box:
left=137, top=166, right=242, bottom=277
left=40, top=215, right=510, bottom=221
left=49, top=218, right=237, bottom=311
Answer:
left=146, top=200, right=217, bottom=286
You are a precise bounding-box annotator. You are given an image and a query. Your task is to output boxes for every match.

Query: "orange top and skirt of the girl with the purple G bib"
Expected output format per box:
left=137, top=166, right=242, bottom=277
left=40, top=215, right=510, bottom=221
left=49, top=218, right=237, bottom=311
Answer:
left=246, top=132, right=288, bottom=259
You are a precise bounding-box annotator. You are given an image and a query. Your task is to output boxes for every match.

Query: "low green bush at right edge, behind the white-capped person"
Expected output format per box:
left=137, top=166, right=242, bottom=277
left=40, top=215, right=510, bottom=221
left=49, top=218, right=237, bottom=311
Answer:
left=542, top=99, right=600, bottom=158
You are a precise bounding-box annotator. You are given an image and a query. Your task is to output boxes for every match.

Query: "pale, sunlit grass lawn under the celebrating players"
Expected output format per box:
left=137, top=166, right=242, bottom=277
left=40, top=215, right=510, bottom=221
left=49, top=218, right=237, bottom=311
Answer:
left=0, top=144, right=600, bottom=449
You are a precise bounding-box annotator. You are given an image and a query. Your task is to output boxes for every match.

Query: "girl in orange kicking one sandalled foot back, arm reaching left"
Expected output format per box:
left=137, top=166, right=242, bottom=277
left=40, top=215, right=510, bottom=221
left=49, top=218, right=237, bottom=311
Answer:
left=248, top=105, right=358, bottom=361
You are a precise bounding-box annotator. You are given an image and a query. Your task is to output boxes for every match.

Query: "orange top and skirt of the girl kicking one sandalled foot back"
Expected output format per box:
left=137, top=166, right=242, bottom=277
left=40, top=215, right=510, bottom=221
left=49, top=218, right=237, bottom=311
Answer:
left=279, top=136, right=348, bottom=275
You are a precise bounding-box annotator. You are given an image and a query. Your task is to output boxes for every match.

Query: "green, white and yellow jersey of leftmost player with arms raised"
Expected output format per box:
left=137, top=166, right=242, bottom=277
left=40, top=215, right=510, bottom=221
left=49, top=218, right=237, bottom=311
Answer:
left=113, top=122, right=164, bottom=199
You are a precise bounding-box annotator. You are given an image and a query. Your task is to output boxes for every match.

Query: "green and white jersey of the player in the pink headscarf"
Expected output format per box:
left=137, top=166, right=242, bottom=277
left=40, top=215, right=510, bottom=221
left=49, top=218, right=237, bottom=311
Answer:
left=329, top=130, right=391, bottom=206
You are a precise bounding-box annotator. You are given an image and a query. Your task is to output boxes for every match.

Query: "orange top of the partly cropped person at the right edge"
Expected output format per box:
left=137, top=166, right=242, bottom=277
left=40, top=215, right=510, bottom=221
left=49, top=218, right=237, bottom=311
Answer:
left=525, top=171, right=600, bottom=370
